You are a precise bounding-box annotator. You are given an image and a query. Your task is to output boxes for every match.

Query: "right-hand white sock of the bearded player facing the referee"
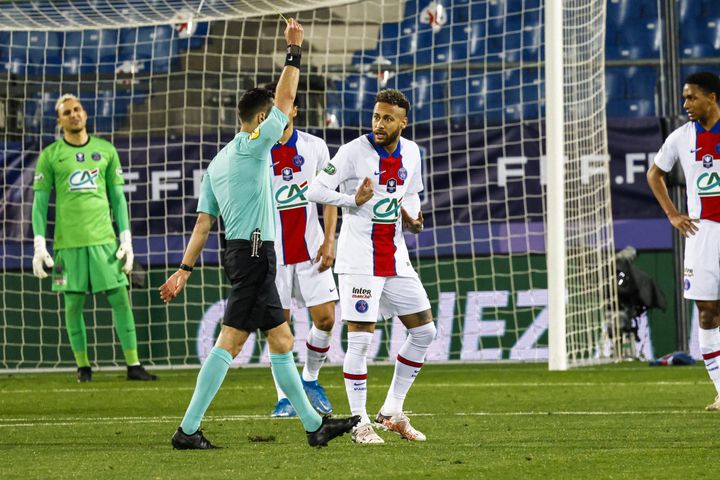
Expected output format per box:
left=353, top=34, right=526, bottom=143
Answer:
left=380, top=322, right=437, bottom=416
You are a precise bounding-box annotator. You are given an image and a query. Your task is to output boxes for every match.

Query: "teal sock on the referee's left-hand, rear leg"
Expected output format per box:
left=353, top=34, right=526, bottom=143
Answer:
left=180, top=347, right=232, bottom=435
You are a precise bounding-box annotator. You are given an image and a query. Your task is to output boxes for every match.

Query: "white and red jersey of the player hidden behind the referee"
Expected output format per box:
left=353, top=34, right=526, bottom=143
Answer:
left=270, top=129, right=330, bottom=265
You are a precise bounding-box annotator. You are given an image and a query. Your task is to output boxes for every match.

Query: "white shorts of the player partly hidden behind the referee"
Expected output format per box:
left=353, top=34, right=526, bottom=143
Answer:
left=275, top=260, right=338, bottom=310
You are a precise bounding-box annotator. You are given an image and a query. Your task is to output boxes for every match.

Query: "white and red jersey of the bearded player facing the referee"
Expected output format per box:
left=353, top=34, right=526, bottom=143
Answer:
left=316, top=134, right=423, bottom=277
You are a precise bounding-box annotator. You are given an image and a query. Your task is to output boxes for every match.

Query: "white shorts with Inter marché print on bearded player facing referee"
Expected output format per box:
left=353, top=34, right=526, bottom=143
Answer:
left=338, top=273, right=430, bottom=322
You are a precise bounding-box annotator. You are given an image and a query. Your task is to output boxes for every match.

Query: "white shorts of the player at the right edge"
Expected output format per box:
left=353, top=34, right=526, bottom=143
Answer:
left=683, top=220, right=720, bottom=300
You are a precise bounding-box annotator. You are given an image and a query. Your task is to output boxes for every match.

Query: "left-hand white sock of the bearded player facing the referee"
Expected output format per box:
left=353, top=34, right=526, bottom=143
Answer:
left=343, top=332, right=373, bottom=424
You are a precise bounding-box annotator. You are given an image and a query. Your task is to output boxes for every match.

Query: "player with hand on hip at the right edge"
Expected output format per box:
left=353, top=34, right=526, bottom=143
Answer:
left=647, top=72, right=720, bottom=411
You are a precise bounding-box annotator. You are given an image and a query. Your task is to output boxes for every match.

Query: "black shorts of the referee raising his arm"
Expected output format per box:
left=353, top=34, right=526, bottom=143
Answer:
left=223, top=240, right=285, bottom=332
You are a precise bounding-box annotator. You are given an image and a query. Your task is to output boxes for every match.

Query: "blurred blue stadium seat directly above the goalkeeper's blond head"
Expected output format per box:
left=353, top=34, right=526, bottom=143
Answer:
left=63, top=30, right=118, bottom=73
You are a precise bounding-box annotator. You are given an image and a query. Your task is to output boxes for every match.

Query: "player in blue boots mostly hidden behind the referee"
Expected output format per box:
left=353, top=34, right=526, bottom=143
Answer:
left=266, top=85, right=338, bottom=417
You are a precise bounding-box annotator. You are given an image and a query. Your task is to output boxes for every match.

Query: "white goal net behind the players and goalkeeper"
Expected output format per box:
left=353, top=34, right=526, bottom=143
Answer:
left=0, top=0, right=616, bottom=370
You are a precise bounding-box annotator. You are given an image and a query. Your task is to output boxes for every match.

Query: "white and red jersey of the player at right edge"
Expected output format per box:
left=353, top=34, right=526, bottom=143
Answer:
left=655, top=122, right=720, bottom=222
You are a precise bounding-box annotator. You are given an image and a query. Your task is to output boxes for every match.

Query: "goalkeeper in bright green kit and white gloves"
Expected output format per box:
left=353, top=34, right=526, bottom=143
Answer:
left=32, top=94, right=157, bottom=382
